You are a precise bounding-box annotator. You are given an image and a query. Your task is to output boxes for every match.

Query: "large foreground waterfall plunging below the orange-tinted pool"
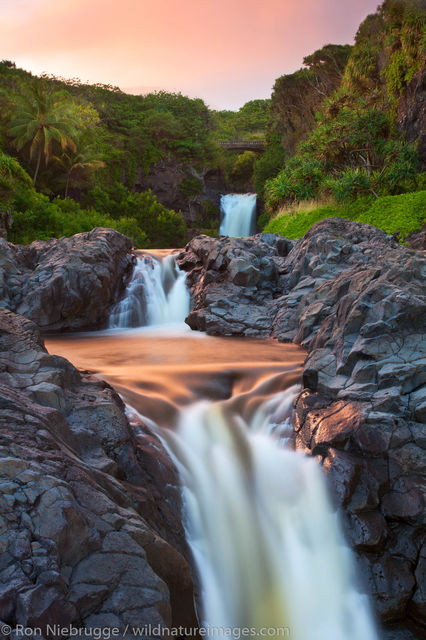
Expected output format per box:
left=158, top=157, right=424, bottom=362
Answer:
left=163, top=387, right=377, bottom=640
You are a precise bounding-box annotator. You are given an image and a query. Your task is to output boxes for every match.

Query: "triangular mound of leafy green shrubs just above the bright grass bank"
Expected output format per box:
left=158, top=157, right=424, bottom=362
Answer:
left=265, top=93, right=419, bottom=210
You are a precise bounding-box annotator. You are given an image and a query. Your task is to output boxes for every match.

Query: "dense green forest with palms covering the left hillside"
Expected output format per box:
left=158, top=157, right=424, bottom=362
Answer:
left=0, top=61, right=216, bottom=247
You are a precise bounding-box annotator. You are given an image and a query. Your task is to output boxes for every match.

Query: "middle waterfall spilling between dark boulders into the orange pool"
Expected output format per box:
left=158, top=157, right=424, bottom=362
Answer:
left=109, top=253, right=190, bottom=328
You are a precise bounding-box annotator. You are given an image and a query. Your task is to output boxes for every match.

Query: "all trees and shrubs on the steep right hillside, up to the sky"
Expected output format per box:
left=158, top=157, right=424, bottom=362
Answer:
left=257, top=0, right=426, bottom=211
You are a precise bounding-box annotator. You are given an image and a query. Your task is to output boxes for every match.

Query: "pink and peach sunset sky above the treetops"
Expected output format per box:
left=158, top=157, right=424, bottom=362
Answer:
left=0, top=0, right=378, bottom=109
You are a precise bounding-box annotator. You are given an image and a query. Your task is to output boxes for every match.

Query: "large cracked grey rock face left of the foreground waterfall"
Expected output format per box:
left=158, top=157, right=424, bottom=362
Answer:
left=0, top=310, right=194, bottom=628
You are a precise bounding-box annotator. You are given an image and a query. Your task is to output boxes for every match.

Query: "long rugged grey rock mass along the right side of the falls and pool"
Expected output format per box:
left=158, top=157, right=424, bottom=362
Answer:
left=179, top=218, right=426, bottom=625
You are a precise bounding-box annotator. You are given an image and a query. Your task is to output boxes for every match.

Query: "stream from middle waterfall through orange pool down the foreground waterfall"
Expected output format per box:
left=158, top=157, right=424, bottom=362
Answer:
left=46, top=251, right=376, bottom=640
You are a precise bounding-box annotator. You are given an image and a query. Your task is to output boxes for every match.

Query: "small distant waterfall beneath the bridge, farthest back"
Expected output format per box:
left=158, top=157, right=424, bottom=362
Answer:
left=219, top=193, right=256, bottom=236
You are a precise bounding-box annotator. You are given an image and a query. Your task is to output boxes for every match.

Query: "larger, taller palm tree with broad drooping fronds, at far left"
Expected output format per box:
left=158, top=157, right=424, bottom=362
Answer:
left=9, top=83, right=76, bottom=184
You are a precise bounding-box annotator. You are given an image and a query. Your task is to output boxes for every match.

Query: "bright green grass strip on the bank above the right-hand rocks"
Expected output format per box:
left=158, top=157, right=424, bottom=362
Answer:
left=263, top=191, right=426, bottom=241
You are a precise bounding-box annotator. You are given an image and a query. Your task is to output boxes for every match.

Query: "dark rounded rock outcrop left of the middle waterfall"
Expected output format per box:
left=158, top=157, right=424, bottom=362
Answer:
left=0, top=228, right=133, bottom=331
